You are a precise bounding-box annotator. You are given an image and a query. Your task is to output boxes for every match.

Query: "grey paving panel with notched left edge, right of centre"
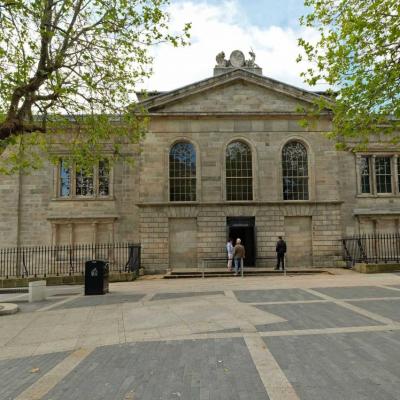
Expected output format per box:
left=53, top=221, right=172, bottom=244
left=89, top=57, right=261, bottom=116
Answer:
left=257, top=302, right=381, bottom=332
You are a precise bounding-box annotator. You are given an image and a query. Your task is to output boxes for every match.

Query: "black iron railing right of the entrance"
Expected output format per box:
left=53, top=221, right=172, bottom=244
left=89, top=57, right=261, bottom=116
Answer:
left=342, top=233, right=400, bottom=265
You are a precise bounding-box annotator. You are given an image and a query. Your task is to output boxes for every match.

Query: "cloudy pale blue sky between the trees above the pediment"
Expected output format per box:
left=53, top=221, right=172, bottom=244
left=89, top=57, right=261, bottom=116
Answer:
left=141, top=0, right=325, bottom=91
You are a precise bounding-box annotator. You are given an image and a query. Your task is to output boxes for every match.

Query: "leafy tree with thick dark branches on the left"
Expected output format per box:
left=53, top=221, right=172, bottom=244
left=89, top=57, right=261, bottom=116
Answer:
left=0, top=0, right=190, bottom=172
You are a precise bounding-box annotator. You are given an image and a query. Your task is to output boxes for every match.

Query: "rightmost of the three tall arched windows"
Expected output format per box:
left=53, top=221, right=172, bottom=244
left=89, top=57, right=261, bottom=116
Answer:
left=282, top=142, right=308, bottom=200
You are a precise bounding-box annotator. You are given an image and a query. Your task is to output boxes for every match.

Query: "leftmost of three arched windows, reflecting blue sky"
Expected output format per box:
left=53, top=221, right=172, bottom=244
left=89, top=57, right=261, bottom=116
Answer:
left=169, top=142, right=196, bottom=201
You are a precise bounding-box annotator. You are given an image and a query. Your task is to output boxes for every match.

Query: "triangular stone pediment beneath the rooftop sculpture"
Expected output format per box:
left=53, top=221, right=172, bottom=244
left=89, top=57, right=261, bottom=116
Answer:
left=141, top=69, right=330, bottom=114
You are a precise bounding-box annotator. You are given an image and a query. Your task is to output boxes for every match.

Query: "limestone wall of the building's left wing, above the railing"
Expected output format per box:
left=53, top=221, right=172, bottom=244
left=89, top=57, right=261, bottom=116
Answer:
left=0, top=156, right=140, bottom=247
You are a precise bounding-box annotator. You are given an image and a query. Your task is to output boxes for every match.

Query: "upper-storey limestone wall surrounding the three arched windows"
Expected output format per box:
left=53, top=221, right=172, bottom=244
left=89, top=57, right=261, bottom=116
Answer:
left=140, top=117, right=340, bottom=203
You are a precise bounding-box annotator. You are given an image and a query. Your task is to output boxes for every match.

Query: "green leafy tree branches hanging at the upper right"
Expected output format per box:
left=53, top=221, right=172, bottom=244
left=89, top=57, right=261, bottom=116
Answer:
left=298, top=0, right=400, bottom=147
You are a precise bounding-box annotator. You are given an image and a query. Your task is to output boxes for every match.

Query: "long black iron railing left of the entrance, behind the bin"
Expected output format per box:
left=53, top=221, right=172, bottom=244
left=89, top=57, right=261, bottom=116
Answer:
left=0, top=243, right=141, bottom=278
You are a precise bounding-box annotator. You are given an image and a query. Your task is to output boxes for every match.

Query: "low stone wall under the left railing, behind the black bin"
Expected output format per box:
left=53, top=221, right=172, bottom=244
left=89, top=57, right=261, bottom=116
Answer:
left=0, top=272, right=137, bottom=288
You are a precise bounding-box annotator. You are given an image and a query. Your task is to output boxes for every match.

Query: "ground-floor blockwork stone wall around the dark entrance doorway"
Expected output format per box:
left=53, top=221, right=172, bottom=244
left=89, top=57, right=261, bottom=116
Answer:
left=140, top=202, right=341, bottom=272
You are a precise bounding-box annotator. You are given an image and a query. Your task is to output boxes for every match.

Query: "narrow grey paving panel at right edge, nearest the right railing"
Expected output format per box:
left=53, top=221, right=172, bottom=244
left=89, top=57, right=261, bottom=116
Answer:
left=313, top=286, right=400, bottom=299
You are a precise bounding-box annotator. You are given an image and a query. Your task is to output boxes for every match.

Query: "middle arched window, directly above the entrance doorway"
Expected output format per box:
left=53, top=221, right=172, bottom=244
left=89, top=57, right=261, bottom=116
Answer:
left=226, top=142, right=253, bottom=200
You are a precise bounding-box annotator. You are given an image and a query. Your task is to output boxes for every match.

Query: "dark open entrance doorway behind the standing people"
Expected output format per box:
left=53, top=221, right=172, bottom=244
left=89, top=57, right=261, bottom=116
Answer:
left=226, top=217, right=256, bottom=267
